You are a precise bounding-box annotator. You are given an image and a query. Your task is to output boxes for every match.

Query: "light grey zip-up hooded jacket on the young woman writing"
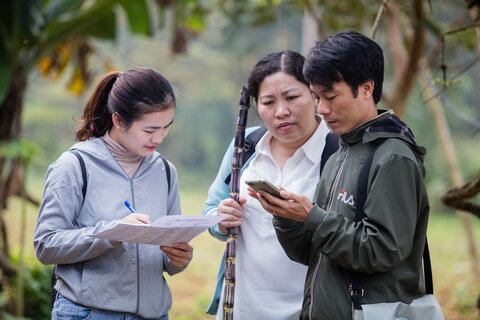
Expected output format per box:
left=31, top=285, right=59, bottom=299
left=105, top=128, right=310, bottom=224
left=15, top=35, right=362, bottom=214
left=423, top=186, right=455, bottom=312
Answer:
left=33, top=138, right=184, bottom=318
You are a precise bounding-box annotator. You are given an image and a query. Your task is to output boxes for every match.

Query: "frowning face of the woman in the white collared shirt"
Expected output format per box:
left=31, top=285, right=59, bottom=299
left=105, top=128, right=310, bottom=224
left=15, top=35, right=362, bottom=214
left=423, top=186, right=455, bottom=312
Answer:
left=257, top=72, right=318, bottom=148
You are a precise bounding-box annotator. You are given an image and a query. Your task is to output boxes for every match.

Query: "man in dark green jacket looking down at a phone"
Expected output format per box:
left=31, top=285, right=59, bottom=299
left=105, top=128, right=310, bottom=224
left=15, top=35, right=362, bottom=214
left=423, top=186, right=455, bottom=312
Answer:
left=250, top=31, right=429, bottom=320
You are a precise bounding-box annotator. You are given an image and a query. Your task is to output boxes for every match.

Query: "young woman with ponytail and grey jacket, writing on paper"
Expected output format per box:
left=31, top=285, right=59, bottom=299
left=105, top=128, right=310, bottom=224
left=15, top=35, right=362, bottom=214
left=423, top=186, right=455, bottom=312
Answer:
left=34, top=68, right=193, bottom=319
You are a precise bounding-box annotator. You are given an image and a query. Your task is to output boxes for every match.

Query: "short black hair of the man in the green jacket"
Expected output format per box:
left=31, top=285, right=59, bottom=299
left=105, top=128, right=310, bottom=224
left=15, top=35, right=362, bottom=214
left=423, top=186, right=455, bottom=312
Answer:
left=303, top=31, right=383, bottom=104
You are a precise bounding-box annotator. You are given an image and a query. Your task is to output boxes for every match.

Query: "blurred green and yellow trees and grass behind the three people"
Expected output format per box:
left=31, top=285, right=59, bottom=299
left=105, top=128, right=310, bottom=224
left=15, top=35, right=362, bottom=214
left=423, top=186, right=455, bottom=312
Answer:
left=0, top=0, right=480, bottom=319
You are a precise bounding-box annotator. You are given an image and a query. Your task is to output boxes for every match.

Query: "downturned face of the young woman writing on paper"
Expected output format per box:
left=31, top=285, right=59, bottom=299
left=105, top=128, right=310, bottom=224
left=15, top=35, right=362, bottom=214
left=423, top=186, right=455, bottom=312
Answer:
left=110, top=105, right=175, bottom=156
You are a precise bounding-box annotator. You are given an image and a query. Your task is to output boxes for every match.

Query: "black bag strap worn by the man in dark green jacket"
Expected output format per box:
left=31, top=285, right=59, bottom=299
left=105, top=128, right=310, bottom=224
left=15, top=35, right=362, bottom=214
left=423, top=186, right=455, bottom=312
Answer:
left=350, top=139, right=433, bottom=310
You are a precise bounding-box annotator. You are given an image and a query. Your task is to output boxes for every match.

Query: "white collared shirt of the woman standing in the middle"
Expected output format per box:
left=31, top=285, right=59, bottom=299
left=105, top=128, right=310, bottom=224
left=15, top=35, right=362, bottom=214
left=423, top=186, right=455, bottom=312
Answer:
left=217, top=121, right=329, bottom=320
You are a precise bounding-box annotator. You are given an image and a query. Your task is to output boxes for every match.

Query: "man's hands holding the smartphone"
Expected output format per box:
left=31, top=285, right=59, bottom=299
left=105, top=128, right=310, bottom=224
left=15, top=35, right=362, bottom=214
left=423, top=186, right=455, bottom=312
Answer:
left=248, top=187, right=313, bottom=222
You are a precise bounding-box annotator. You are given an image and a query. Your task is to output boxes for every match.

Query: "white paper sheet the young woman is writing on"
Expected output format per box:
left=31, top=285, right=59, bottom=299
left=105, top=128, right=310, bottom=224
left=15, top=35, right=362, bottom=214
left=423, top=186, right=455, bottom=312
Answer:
left=88, top=215, right=226, bottom=246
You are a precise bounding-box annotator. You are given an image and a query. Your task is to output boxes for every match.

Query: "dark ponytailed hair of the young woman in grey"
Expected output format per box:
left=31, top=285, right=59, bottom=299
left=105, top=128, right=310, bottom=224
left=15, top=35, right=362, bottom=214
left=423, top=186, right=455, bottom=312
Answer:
left=75, top=68, right=175, bottom=141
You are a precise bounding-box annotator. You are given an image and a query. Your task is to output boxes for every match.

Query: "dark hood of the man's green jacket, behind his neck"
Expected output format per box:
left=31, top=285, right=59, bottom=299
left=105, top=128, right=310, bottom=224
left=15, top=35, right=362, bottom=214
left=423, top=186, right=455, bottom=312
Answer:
left=342, top=110, right=427, bottom=162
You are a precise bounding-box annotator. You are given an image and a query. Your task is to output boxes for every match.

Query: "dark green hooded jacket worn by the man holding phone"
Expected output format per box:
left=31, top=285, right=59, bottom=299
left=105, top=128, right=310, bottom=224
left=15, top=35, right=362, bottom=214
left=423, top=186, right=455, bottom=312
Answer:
left=274, top=111, right=429, bottom=320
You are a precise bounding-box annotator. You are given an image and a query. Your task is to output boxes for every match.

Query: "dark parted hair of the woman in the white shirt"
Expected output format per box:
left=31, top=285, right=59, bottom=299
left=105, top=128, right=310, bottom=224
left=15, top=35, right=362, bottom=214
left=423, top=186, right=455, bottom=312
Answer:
left=248, top=50, right=308, bottom=102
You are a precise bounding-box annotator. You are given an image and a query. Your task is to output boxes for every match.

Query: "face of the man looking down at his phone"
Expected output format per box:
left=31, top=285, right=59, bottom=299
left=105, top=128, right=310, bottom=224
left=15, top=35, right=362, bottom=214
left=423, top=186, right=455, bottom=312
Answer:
left=310, top=80, right=377, bottom=135
